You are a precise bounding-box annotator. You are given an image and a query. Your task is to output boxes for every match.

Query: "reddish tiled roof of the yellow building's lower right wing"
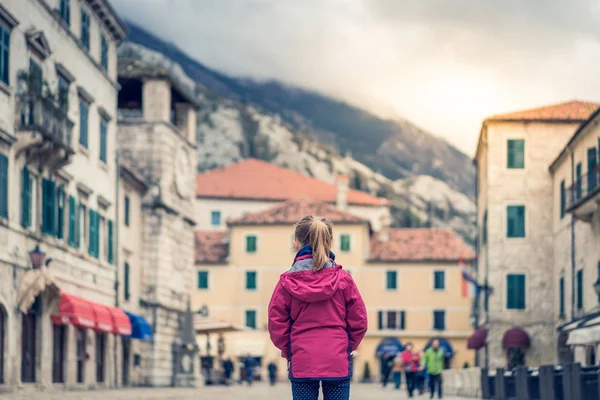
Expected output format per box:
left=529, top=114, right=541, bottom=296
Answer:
left=369, top=228, right=475, bottom=262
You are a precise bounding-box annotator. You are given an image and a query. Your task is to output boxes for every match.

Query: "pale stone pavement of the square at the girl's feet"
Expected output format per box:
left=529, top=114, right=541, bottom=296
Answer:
left=0, top=383, right=468, bottom=400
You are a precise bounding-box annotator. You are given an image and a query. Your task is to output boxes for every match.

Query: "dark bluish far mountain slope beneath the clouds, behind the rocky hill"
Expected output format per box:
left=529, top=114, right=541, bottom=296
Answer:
left=128, top=23, right=474, bottom=197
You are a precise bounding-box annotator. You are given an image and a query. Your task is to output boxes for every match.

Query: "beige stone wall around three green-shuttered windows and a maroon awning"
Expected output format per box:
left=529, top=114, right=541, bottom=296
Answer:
left=477, top=122, right=578, bottom=368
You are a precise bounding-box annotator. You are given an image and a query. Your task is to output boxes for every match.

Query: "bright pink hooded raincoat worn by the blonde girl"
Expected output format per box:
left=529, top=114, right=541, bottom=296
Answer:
left=269, top=256, right=367, bottom=380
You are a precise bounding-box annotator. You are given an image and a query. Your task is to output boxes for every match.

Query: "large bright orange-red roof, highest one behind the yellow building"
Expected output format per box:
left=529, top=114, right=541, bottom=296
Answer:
left=196, top=159, right=388, bottom=205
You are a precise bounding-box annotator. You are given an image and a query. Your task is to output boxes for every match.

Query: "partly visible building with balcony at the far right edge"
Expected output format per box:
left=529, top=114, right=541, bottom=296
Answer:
left=550, top=111, right=600, bottom=365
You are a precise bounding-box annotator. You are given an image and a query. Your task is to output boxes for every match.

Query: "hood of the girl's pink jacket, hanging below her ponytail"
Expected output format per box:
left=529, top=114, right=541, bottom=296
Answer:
left=280, top=265, right=343, bottom=303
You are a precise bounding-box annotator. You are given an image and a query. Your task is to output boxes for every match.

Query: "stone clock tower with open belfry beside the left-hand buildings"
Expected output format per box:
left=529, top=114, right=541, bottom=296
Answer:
left=118, top=46, right=199, bottom=386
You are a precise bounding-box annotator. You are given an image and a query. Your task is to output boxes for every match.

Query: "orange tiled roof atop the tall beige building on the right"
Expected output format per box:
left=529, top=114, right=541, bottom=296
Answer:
left=486, top=100, right=600, bottom=122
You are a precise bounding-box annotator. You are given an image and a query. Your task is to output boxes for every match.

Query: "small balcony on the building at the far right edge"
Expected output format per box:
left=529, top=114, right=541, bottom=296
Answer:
left=566, top=167, right=600, bottom=221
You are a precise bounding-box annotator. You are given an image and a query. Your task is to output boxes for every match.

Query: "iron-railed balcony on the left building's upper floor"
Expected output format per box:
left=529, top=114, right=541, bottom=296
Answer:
left=16, top=93, right=75, bottom=170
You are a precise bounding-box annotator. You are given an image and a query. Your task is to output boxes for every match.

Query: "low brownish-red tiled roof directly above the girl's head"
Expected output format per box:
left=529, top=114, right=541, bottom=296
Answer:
left=227, top=200, right=368, bottom=225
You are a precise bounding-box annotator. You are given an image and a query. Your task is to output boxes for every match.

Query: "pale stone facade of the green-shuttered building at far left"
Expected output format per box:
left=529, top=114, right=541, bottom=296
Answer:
left=0, top=0, right=125, bottom=391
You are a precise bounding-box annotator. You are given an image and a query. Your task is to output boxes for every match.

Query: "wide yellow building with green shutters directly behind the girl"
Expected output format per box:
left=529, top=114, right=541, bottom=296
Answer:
left=190, top=198, right=474, bottom=379
